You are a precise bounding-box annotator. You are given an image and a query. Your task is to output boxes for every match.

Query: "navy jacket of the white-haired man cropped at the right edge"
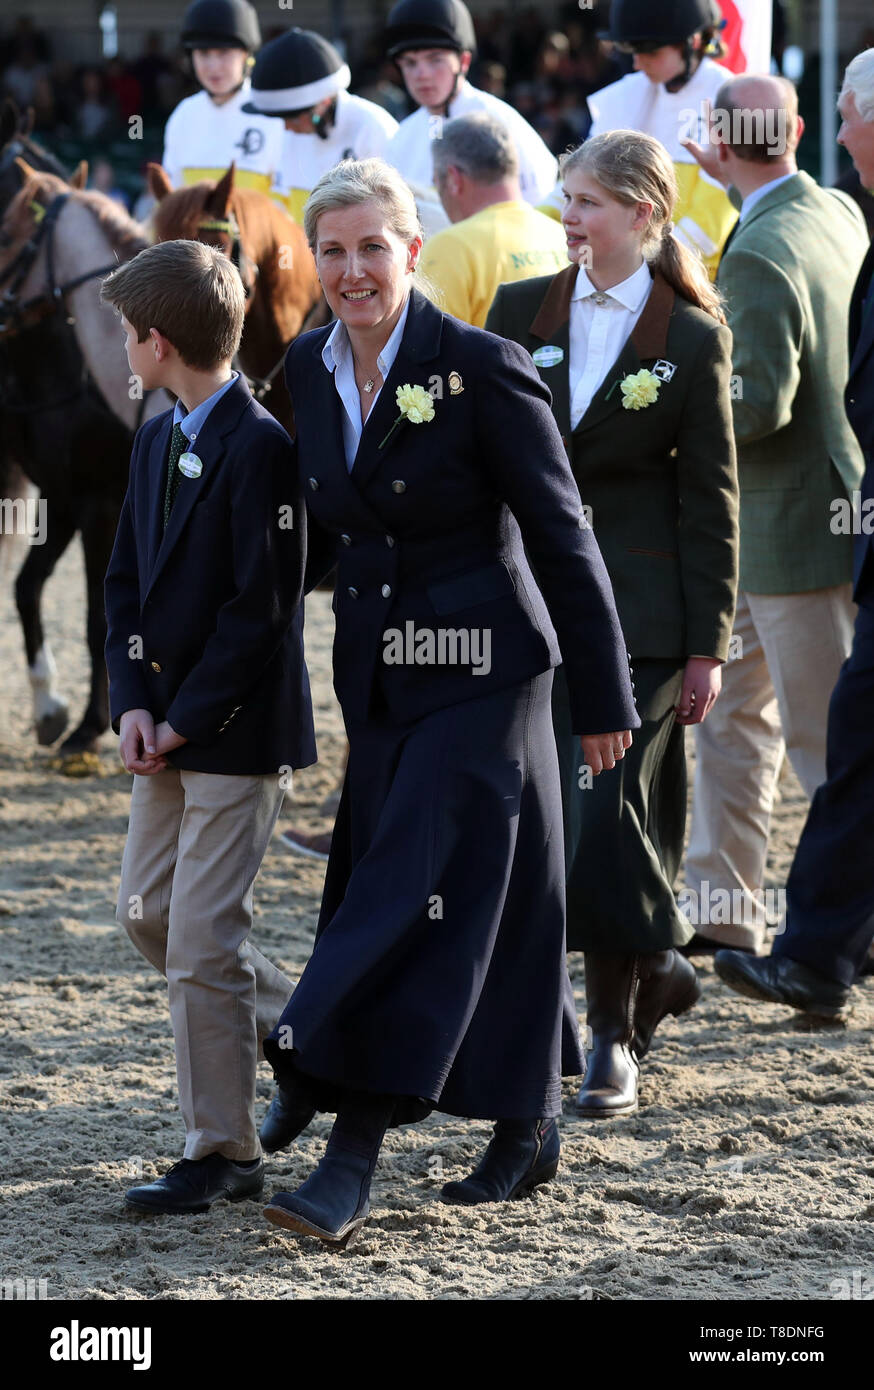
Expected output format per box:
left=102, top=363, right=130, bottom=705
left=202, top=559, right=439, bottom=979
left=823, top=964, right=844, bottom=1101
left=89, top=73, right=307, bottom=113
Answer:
left=843, top=246, right=874, bottom=607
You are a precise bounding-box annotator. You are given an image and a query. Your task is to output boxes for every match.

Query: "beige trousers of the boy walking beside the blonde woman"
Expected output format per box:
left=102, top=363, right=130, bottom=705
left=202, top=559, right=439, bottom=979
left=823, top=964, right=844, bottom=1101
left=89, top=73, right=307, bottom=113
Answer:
left=117, top=767, right=293, bottom=1162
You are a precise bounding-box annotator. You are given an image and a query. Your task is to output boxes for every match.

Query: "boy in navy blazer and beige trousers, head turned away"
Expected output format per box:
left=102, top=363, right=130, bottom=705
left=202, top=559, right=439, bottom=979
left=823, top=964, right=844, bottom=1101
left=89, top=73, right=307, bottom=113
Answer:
left=103, top=242, right=315, bottom=1212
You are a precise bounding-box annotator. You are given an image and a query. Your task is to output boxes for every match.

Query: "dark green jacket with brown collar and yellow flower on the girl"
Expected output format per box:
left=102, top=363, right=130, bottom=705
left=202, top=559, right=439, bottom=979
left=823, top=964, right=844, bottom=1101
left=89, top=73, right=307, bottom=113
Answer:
left=485, top=265, right=738, bottom=662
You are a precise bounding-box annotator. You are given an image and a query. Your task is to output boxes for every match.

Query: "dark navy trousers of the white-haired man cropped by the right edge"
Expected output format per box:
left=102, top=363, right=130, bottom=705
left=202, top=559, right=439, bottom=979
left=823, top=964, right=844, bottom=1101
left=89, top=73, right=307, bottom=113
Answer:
left=771, top=607, right=874, bottom=986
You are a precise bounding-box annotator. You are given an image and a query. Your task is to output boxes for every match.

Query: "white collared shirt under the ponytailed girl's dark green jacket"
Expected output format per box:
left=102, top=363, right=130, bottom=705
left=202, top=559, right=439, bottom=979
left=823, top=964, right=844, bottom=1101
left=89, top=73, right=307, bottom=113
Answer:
left=568, top=261, right=653, bottom=430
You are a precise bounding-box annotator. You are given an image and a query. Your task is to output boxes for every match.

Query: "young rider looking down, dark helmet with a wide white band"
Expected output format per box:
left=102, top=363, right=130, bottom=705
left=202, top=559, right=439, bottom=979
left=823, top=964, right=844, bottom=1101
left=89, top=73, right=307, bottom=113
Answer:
left=243, top=28, right=397, bottom=222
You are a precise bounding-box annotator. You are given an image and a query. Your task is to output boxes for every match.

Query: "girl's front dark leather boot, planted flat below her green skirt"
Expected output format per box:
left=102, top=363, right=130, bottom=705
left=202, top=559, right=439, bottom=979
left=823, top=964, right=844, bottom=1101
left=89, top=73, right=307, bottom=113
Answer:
left=574, top=952, right=641, bottom=1119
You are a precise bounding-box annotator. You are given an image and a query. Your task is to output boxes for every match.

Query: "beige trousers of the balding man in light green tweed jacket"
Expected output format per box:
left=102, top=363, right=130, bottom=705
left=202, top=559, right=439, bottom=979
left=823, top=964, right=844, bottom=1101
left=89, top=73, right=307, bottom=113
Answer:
left=681, top=584, right=856, bottom=952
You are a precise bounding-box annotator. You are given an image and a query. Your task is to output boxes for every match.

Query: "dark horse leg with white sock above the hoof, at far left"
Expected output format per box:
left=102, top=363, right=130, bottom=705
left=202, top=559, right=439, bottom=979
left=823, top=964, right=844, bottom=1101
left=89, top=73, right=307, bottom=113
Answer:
left=15, top=494, right=76, bottom=744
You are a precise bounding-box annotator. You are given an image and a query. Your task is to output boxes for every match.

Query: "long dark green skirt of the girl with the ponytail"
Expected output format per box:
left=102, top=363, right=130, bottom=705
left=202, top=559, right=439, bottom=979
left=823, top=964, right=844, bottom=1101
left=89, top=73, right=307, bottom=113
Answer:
left=553, top=657, right=695, bottom=955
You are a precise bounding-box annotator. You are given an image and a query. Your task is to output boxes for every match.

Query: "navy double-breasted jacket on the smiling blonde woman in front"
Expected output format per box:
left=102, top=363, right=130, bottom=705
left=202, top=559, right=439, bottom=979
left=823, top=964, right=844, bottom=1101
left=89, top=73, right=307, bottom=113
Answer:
left=285, top=289, right=639, bottom=734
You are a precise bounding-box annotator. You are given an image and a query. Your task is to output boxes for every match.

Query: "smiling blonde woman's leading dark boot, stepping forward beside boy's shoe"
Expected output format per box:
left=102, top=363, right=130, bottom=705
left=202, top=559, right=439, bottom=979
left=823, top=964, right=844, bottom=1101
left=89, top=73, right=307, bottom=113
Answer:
left=264, top=1091, right=395, bottom=1245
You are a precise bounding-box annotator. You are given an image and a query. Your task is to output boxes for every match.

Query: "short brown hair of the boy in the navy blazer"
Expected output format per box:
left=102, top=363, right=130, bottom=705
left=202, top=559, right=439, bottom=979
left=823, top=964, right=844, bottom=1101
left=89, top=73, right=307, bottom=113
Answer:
left=100, top=240, right=246, bottom=371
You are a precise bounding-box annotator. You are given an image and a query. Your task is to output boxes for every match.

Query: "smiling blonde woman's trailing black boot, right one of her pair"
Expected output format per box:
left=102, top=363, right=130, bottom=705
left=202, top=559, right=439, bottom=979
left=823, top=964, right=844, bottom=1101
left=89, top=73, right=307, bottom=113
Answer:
left=440, top=1119, right=561, bottom=1207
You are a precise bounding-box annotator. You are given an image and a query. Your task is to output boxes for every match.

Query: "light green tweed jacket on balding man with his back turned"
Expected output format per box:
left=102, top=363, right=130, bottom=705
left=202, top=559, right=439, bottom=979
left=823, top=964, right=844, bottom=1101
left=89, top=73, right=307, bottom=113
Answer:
left=717, top=172, right=868, bottom=594
